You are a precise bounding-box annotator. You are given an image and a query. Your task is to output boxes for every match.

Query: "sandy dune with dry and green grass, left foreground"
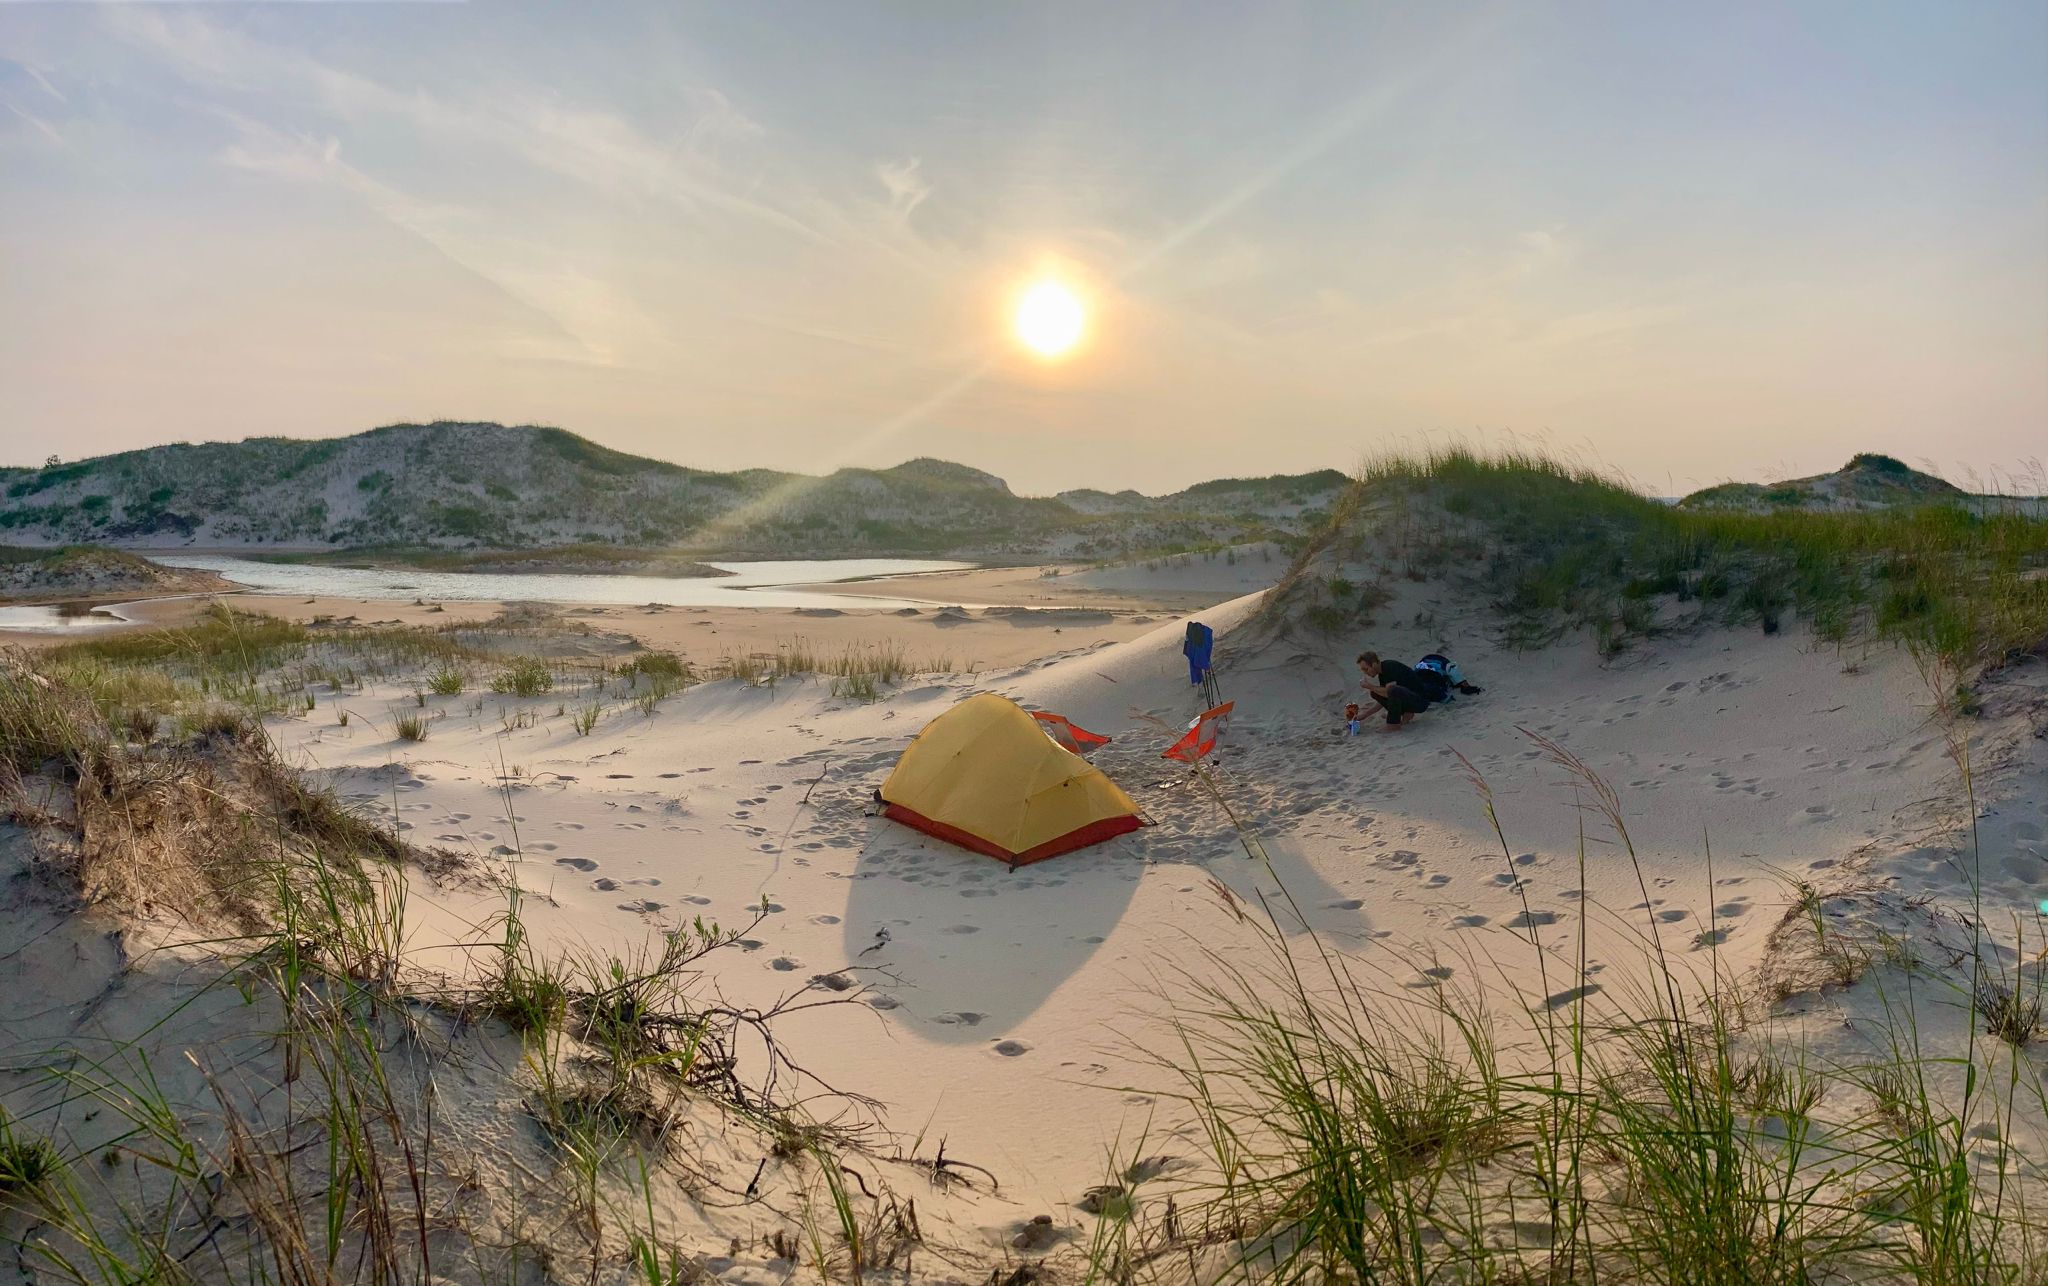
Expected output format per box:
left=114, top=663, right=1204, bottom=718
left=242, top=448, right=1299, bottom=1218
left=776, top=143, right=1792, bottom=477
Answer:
left=0, top=608, right=999, bottom=1286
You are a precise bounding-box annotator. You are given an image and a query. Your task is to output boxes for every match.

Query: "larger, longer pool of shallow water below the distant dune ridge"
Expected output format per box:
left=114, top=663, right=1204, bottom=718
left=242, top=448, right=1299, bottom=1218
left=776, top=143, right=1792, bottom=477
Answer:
left=152, top=555, right=973, bottom=608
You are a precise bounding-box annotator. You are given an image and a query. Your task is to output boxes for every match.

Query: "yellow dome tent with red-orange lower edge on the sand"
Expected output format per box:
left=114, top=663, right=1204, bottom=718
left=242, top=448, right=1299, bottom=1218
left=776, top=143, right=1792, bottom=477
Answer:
left=881, top=692, right=1145, bottom=866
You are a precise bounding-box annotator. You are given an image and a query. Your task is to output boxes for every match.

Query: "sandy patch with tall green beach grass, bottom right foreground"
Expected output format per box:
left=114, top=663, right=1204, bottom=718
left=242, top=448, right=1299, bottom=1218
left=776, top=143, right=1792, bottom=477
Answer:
left=1092, top=737, right=2048, bottom=1286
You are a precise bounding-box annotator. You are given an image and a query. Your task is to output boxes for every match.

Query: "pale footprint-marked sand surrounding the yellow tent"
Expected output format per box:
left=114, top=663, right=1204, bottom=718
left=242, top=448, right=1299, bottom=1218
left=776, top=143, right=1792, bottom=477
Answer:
left=247, top=556, right=2048, bottom=1214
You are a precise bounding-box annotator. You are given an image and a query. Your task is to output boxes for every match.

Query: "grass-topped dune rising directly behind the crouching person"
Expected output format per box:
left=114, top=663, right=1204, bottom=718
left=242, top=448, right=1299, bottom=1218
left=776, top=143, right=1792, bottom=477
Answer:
left=1266, top=451, right=2048, bottom=670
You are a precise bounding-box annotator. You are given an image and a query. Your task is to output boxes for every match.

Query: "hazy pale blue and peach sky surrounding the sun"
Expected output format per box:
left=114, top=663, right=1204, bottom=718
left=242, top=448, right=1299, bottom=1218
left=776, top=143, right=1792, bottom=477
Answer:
left=0, top=0, right=2048, bottom=494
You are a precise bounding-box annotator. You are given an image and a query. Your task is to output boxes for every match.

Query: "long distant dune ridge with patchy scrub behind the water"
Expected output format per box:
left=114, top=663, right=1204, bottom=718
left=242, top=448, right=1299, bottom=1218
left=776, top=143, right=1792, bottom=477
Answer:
left=0, top=422, right=1348, bottom=557
